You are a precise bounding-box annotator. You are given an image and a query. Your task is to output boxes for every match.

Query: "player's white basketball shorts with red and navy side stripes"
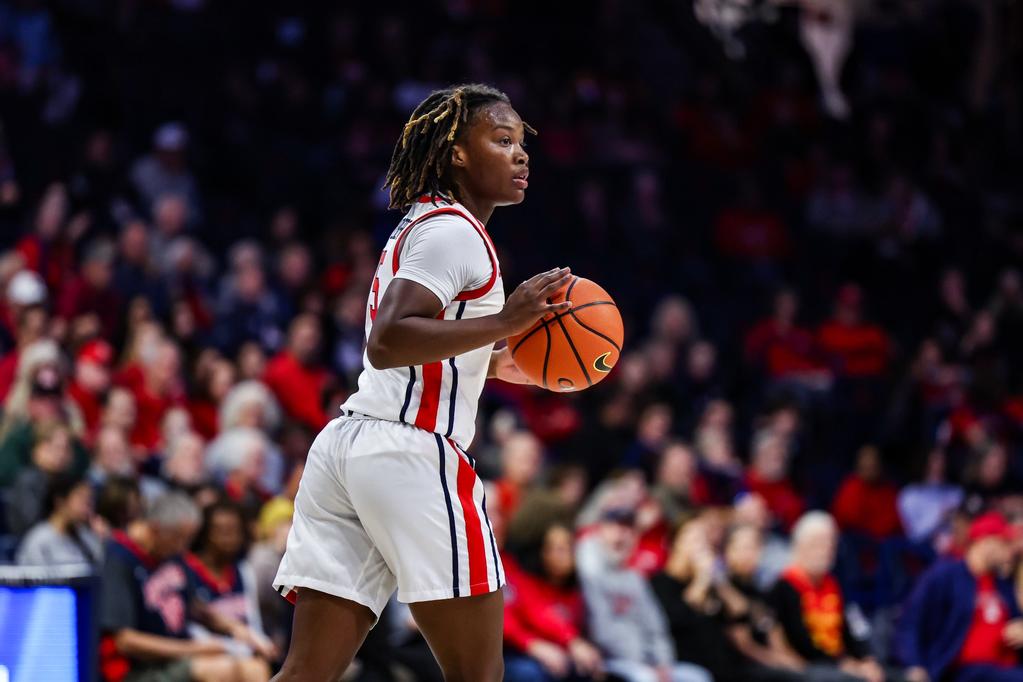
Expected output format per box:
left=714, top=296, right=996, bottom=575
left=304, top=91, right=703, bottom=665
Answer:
left=273, top=415, right=504, bottom=617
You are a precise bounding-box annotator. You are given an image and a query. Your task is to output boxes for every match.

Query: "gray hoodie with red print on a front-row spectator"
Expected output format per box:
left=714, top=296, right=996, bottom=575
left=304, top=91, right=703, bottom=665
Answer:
left=576, top=537, right=675, bottom=666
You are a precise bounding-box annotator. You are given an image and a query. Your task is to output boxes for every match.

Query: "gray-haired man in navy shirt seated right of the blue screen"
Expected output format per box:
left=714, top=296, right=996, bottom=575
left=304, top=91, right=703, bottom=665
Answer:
left=99, top=493, right=270, bottom=682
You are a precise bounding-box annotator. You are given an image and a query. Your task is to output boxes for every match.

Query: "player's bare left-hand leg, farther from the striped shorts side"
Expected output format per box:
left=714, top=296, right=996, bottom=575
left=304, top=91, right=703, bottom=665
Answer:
left=274, top=588, right=376, bottom=682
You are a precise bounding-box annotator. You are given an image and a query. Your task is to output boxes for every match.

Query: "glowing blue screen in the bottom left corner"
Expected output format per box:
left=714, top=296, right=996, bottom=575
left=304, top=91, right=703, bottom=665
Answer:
left=0, top=586, right=79, bottom=682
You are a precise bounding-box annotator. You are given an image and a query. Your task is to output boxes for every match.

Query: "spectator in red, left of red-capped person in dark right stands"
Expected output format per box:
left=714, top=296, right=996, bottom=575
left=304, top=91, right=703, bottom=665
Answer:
left=745, top=289, right=830, bottom=384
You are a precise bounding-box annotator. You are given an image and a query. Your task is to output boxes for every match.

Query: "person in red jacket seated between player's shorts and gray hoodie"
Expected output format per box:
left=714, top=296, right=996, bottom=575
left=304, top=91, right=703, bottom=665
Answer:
left=502, top=522, right=604, bottom=682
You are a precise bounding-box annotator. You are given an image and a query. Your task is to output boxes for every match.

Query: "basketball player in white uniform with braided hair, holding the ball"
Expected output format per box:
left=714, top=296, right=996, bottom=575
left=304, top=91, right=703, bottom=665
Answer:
left=274, top=85, right=571, bottom=682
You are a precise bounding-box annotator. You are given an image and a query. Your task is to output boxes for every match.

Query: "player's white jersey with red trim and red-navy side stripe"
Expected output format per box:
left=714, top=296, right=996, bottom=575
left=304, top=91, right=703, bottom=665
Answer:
left=342, top=197, right=504, bottom=448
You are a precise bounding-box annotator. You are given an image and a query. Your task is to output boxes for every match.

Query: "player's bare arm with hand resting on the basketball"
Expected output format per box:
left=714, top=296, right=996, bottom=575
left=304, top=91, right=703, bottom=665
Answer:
left=366, top=268, right=572, bottom=369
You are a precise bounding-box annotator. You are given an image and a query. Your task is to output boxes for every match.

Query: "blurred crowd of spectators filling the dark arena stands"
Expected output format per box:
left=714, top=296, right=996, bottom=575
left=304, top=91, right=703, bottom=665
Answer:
left=0, top=0, right=1023, bottom=682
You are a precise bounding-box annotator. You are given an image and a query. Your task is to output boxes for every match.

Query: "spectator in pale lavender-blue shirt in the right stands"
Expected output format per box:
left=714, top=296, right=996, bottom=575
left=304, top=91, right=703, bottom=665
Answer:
left=896, top=449, right=964, bottom=543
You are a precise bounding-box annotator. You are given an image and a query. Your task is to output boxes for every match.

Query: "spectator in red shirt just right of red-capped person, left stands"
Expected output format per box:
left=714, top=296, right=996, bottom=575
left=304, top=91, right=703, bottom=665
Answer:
left=117, top=338, right=183, bottom=453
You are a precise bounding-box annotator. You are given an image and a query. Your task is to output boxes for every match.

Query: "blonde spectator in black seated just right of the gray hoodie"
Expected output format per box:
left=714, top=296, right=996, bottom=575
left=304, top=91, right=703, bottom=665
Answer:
left=651, top=518, right=800, bottom=682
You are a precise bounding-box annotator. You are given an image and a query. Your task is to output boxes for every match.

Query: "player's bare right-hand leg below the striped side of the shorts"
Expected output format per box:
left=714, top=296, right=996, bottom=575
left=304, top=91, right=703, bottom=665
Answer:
left=409, top=590, right=504, bottom=682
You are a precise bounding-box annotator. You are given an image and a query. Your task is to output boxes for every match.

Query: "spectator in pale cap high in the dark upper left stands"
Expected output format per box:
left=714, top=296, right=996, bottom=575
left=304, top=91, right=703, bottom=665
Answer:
left=131, top=122, right=198, bottom=218
